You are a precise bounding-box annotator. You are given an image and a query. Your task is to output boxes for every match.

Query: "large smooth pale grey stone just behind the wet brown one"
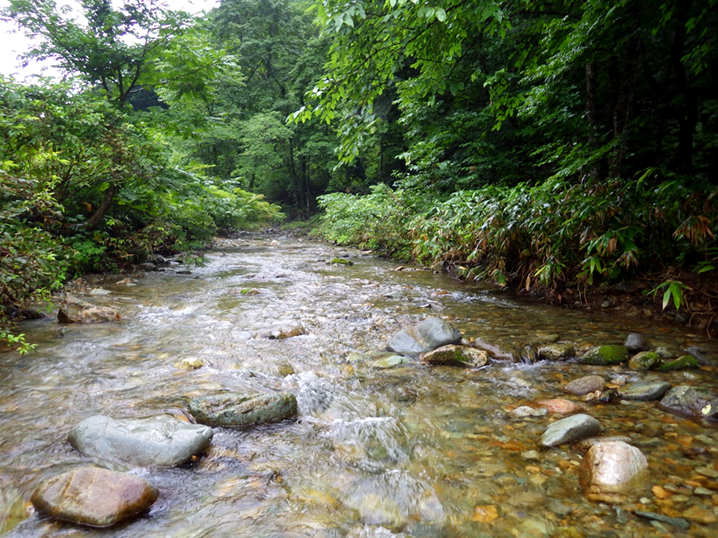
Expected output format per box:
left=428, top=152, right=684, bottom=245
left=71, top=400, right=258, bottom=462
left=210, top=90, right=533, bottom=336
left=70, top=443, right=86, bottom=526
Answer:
left=68, top=415, right=213, bottom=467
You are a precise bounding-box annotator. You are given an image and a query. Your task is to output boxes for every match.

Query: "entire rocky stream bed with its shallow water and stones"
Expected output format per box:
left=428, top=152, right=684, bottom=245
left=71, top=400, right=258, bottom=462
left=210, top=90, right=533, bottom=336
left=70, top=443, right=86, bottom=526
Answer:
left=0, top=236, right=718, bottom=537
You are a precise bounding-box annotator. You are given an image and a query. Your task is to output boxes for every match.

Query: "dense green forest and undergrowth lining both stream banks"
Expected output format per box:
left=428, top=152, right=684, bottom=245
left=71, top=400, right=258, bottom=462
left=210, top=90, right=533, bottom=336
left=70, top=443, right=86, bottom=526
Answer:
left=0, top=0, right=718, bottom=351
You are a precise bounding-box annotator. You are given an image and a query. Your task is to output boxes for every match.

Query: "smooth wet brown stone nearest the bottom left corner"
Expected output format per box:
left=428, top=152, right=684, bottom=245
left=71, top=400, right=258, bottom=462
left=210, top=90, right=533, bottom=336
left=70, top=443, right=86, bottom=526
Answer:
left=32, top=467, right=158, bottom=528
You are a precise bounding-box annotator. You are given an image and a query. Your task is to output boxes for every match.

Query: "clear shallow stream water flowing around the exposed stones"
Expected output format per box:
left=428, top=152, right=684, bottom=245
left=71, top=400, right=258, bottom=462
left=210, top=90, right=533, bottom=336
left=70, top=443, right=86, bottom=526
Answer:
left=0, top=237, right=718, bottom=538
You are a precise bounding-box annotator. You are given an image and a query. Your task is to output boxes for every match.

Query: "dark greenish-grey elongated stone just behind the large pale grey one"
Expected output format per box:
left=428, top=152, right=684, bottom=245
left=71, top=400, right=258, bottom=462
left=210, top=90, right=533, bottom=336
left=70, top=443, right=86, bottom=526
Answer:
left=189, top=392, right=297, bottom=426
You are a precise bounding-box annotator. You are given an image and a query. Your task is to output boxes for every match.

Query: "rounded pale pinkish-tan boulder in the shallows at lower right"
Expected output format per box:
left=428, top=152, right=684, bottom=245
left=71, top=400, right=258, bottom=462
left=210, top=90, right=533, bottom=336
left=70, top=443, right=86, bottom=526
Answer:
left=579, top=441, right=648, bottom=502
